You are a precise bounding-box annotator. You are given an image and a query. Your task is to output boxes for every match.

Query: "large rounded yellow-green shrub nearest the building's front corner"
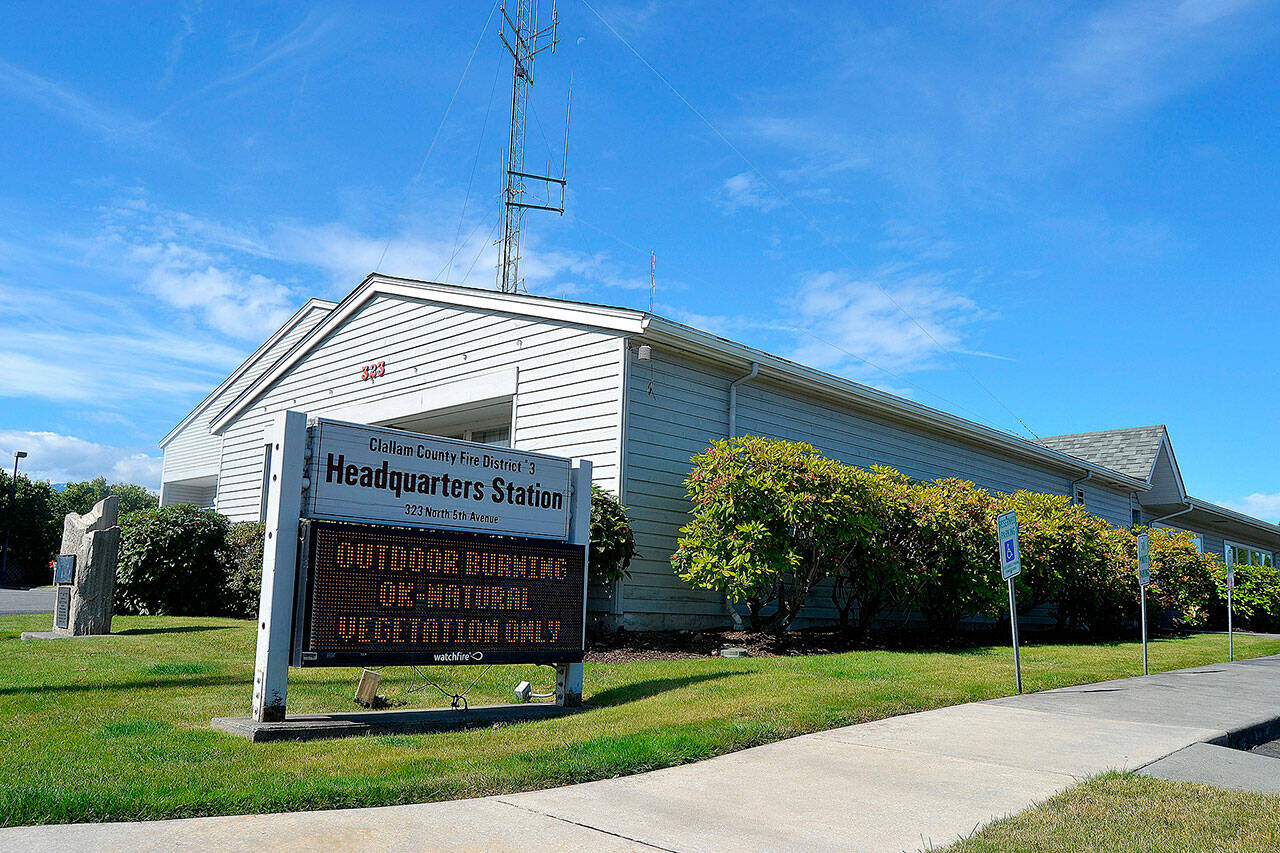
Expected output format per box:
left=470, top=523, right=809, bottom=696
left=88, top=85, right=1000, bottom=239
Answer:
left=672, top=435, right=872, bottom=630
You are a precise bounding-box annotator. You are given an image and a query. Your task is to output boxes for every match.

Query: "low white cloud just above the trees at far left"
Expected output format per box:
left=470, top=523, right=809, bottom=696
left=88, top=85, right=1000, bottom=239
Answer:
left=0, top=429, right=164, bottom=491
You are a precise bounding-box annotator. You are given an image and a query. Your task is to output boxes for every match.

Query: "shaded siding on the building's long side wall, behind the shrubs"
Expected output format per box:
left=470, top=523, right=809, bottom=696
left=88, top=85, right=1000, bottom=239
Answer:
left=622, top=347, right=1130, bottom=626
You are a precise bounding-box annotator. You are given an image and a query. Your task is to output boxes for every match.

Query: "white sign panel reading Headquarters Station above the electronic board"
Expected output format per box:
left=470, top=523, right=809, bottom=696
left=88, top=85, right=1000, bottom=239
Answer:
left=302, top=418, right=572, bottom=542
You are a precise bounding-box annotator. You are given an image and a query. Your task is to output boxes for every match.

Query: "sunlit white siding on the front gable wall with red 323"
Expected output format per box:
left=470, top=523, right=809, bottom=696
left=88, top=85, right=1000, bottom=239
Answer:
left=218, top=295, right=623, bottom=520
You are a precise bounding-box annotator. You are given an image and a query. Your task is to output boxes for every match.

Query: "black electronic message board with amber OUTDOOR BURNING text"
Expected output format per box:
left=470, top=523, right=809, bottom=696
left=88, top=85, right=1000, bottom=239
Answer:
left=292, top=521, right=586, bottom=666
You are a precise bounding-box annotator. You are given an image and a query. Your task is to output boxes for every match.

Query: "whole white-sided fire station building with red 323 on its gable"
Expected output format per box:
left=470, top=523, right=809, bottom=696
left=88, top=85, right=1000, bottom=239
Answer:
left=160, top=274, right=1280, bottom=629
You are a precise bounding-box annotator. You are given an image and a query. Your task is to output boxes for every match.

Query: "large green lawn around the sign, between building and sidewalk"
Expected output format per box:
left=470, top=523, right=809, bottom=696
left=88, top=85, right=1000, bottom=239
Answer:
left=0, top=615, right=1280, bottom=825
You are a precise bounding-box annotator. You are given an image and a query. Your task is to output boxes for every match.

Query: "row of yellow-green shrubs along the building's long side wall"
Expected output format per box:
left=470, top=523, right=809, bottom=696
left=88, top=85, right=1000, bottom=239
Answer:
left=672, top=435, right=1264, bottom=635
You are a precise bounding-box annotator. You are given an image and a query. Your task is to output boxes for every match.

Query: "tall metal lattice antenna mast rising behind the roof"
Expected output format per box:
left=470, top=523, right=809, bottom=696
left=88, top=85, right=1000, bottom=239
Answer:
left=498, top=0, right=572, bottom=293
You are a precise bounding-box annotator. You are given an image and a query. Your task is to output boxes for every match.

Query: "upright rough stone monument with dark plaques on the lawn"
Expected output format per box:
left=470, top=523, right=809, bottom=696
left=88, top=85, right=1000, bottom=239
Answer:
left=52, top=494, right=120, bottom=637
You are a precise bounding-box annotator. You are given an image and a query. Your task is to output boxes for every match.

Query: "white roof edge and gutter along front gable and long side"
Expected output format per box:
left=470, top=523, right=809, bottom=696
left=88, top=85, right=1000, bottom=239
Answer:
left=211, top=273, right=1149, bottom=491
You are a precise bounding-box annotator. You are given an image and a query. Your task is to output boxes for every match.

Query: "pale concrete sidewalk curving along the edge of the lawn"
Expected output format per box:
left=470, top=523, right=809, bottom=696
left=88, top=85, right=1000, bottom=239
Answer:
left=0, top=656, right=1280, bottom=852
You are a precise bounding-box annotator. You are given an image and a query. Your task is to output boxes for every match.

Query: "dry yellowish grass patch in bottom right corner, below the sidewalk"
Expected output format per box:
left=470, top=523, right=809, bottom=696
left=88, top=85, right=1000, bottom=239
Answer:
left=947, top=774, right=1280, bottom=853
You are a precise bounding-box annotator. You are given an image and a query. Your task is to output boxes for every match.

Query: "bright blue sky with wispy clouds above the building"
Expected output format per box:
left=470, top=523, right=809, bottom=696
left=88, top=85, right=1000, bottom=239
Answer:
left=0, top=0, right=1280, bottom=520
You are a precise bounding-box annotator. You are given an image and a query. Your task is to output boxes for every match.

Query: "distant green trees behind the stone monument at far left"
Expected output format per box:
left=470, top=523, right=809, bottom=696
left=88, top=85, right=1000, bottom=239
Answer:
left=0, top=473, right=160, bottom=585
